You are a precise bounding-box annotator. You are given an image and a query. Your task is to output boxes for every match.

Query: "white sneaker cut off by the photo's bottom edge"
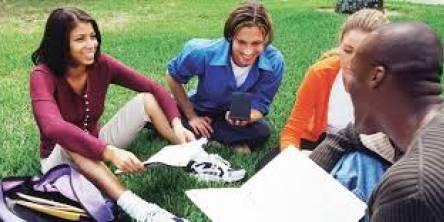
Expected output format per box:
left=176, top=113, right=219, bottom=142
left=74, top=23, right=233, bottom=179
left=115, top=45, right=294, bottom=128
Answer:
left=136, top=202, right=188, bottom=222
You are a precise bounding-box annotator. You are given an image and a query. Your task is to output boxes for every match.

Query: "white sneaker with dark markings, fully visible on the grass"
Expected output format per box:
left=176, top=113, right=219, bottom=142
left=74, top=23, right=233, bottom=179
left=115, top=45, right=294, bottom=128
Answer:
left=189, top=154, right=245, bottom=182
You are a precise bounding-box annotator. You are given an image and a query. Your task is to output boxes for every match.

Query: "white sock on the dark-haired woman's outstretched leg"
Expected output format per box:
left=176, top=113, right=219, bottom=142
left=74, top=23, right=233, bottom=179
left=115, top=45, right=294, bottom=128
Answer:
left=117, top=190, right=174, bottom=221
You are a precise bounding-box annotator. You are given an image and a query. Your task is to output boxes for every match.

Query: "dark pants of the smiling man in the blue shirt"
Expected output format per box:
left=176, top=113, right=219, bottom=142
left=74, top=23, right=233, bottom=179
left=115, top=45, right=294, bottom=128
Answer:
left=182, top=112, right=271, bottom=150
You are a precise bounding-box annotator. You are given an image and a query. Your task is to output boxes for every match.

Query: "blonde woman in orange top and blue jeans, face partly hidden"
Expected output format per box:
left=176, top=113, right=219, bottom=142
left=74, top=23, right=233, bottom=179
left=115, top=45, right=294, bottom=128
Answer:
left=258, top=9, right=392, bottom=214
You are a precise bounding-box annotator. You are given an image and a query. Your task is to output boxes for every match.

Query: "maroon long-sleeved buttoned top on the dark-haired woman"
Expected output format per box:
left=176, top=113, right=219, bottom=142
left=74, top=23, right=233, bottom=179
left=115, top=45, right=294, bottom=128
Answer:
left=30, top=54, right=179, bottom=160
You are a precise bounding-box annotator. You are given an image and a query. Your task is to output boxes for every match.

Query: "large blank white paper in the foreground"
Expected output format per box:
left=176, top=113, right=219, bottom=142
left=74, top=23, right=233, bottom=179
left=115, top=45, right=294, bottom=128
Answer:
left=186, top=149, right=366, bottom=222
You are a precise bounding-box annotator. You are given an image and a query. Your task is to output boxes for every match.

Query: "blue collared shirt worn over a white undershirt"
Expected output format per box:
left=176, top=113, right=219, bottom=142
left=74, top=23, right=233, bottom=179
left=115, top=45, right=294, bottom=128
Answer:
left=168, top=38, right=284, bottom=115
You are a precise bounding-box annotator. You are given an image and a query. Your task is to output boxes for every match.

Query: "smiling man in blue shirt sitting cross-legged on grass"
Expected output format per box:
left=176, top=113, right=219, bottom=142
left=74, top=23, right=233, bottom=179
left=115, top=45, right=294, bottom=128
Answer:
left=166, top=2, right=284, bottom=153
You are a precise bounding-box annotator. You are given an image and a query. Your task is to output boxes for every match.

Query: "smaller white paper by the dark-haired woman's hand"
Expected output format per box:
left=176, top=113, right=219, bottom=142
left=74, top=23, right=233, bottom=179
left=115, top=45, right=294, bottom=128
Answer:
left=143, top=138, right=207, bottom=167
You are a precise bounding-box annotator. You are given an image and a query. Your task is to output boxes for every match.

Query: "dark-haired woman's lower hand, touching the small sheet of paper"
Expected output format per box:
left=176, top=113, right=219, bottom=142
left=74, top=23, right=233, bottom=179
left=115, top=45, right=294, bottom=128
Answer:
left=103, top=145, right=144, bottom=173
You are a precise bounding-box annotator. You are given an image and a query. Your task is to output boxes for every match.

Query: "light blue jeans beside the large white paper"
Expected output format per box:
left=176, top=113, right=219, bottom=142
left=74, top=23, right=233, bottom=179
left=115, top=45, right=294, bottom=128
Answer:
left=330, top=151, right=389, bottom=221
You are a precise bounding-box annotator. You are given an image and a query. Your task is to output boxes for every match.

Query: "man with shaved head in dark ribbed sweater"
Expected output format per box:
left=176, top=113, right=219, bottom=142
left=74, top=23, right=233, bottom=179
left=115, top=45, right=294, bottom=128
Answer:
left=310, top=22, right=444, bottom=222
